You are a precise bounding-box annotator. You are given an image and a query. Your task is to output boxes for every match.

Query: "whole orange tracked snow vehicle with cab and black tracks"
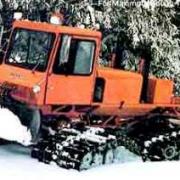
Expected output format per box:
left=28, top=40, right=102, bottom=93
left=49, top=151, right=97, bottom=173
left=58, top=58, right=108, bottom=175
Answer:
left=0, top=20, right=180, bottom=170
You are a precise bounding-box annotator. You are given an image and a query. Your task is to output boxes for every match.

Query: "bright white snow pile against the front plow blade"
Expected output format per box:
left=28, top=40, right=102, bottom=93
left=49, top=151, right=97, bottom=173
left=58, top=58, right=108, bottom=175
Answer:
left=0, top=108, right=32, bottom=146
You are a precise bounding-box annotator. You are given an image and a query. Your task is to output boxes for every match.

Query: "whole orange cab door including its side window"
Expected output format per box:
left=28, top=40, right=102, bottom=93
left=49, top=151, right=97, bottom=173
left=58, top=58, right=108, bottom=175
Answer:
left=46, top=35, right=97, bottom=105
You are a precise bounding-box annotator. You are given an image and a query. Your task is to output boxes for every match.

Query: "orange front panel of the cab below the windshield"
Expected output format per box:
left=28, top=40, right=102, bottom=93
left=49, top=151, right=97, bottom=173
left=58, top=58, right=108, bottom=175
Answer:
left=0, top=64, right=46, bottom=105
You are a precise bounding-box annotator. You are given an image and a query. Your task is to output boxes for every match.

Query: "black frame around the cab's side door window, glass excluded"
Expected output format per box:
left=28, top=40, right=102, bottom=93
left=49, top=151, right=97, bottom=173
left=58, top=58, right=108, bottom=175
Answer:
left=52, top=34, right=97, bottom=77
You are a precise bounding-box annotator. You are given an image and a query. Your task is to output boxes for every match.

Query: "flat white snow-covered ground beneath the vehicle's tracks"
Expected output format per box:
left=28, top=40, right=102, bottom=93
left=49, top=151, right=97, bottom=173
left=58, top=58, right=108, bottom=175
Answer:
left=0, top=144, right=180, bottom=180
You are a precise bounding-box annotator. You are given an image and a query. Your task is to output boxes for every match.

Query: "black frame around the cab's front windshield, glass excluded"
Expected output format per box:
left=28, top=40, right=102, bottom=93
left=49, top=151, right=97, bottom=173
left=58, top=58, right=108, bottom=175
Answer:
left=4, top=27, right=56, bottom=72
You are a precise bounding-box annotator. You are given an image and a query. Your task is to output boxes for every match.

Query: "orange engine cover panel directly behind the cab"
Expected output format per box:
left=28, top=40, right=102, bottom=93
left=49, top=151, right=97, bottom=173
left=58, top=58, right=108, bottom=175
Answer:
left=98, top=68, right=142, bottom=105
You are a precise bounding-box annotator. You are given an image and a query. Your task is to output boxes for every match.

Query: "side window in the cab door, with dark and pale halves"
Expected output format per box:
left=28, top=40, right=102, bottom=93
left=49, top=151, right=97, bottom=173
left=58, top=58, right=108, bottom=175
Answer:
left=53, top=35, right=95, bottom=75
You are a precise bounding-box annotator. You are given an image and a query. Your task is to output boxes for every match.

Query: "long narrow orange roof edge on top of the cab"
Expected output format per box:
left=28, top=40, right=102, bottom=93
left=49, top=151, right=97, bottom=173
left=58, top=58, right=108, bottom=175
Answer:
left=13, top=20, right=102, bottom=38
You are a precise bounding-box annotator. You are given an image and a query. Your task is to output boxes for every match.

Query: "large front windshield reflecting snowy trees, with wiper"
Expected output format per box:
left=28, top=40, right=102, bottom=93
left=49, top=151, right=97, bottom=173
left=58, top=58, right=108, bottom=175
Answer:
left=6, top=29, right=54, bottom=71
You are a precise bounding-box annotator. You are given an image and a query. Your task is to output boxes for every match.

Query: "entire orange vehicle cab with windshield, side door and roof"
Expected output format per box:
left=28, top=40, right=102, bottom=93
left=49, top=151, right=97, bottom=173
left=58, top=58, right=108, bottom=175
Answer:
left=0, top=20, right=101, bottom=106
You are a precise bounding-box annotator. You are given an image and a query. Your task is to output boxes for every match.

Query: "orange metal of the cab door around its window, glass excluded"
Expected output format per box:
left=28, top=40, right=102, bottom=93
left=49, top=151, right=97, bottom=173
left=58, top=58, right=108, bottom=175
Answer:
left=46, top=36, right=100, bottom=105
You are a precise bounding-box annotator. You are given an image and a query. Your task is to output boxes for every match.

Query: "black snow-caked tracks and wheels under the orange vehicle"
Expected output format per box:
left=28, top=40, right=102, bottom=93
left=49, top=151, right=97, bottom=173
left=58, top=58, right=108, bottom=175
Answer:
left=32, top=117, right=180, bottom=170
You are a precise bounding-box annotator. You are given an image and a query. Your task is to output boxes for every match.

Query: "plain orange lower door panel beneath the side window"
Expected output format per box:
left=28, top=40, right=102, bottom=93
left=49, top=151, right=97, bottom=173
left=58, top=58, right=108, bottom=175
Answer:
left=46, top=74, right=94, bottom=105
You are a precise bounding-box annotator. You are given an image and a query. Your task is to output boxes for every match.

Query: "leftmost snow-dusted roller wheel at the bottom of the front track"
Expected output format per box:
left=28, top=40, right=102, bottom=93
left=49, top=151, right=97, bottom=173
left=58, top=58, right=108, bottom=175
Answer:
left=79, top=152, right=93, bottom=171
